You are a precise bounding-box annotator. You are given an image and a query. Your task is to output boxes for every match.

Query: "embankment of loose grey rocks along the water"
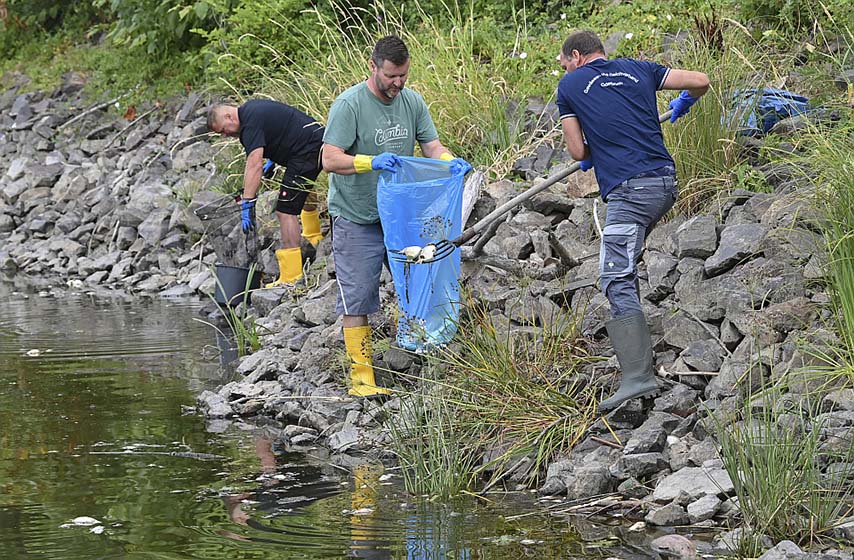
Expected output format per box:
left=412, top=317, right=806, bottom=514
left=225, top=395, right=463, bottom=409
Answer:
left=0, top=72, right=854, bottom=559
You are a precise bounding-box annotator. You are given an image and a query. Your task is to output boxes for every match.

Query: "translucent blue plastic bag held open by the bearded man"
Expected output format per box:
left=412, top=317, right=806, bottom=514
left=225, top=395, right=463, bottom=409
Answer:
left=377, top=157, right=464, bottom=351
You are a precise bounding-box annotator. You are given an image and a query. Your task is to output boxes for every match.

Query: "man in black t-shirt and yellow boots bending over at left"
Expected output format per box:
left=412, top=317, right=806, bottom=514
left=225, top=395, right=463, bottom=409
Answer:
left=207, top=99, right=324, bottom=288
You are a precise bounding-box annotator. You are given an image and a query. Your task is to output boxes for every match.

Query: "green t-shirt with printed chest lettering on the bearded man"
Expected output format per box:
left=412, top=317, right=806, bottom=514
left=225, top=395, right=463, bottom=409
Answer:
left=323, top=82, right=439, bottom=224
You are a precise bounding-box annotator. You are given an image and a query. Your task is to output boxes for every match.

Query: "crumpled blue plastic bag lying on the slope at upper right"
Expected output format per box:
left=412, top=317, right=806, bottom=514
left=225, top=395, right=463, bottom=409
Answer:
left=726, top=88, right=809, bottom=136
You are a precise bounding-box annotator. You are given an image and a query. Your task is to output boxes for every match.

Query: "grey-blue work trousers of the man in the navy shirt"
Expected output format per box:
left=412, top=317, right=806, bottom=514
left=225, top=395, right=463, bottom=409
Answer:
left=599, top=175, right=678, bottom=317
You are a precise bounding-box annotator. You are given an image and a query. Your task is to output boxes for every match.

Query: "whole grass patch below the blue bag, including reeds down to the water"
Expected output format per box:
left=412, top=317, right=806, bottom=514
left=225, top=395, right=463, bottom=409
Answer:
left=391, top=300, right=597, bottom=495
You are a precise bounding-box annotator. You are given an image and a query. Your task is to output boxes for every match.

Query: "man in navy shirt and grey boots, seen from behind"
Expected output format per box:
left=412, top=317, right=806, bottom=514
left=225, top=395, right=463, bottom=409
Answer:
left=557, top=31, right=709, bottom=413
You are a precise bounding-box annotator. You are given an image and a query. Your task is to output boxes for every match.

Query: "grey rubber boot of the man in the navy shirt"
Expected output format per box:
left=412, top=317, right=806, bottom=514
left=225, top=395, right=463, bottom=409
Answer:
left=599, top=313, right=658, bottom=414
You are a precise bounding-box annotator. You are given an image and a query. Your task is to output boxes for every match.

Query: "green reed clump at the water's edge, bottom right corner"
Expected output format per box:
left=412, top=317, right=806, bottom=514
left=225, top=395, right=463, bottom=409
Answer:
left=714, top=393, right=854, bottom=558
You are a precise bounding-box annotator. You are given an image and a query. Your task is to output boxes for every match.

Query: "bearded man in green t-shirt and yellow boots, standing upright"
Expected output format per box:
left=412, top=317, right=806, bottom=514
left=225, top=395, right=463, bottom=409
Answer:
left=323, top=35, right=471, bottom=397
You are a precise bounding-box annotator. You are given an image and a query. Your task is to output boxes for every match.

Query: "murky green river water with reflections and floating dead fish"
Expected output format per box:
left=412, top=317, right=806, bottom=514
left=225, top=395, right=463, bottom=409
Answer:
left=0, top=282, right=656, bottom=560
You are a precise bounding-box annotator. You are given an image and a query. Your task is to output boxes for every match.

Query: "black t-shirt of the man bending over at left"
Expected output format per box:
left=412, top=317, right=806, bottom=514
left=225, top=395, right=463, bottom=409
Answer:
left=237, top=99, right=323, bottom=166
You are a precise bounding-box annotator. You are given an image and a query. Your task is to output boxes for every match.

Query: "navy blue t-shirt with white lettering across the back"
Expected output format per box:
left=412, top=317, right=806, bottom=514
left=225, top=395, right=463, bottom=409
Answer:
left=557, top=58, right=673, bottom=199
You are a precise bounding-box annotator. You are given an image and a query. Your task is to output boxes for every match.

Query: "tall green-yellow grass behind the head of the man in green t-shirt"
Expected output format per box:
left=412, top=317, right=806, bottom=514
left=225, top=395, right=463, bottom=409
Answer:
left=221, top=0, right=556, bottom=176
